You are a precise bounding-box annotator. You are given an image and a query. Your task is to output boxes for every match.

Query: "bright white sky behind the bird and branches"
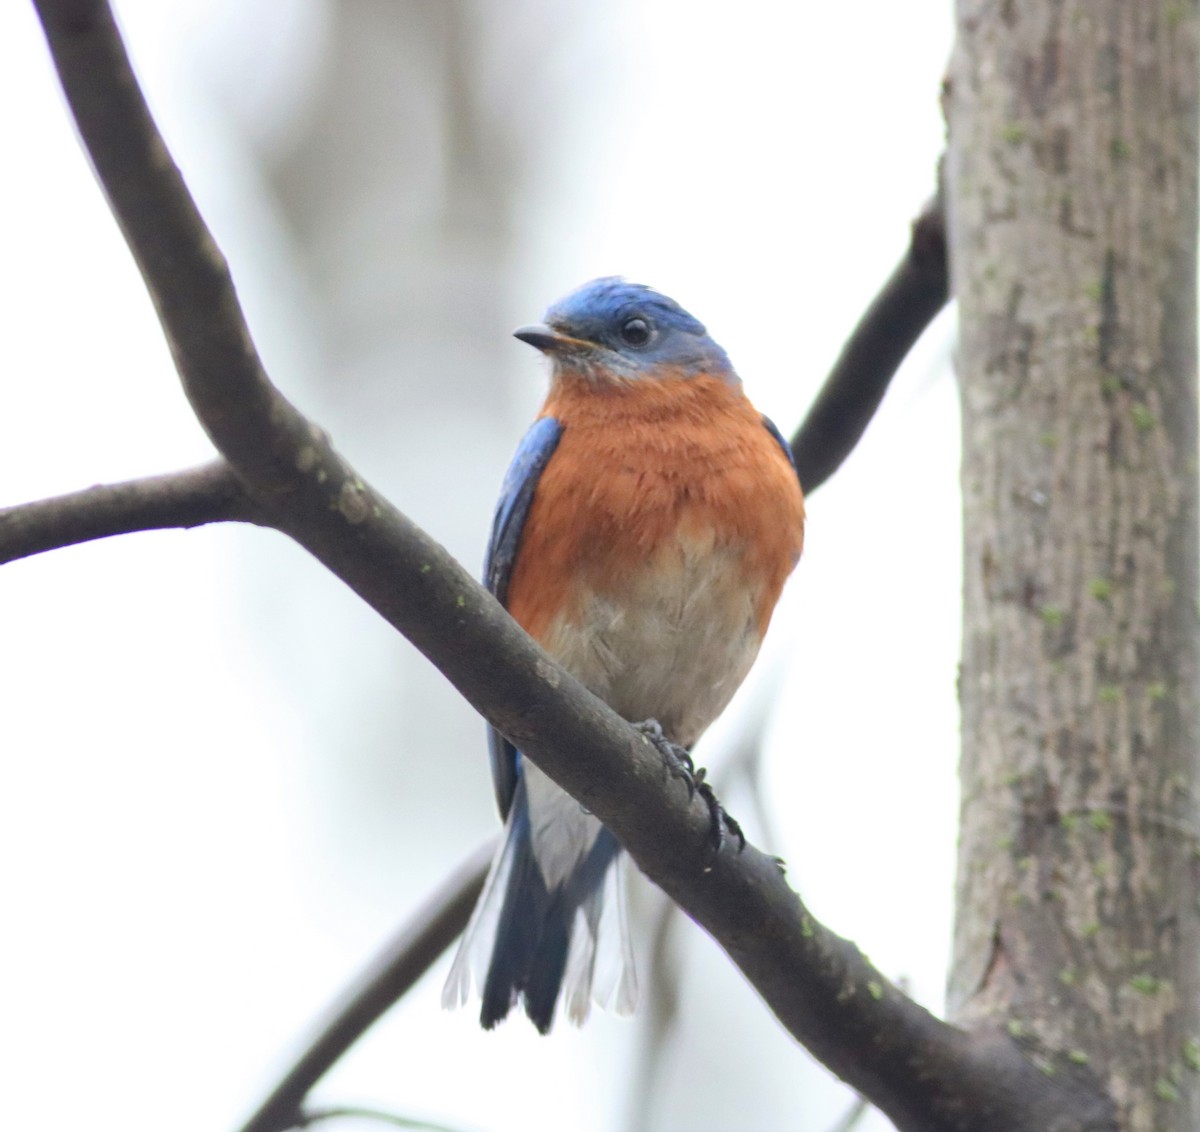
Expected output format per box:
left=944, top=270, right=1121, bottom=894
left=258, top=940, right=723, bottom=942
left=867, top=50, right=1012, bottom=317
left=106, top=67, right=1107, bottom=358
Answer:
left=0, top=0, right=959, bottom=1132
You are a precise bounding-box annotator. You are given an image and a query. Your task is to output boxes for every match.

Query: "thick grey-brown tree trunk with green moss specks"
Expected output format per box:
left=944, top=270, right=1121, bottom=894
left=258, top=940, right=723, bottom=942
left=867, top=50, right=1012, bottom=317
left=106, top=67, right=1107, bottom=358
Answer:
left=947, top=0, right=1200, bottom=1132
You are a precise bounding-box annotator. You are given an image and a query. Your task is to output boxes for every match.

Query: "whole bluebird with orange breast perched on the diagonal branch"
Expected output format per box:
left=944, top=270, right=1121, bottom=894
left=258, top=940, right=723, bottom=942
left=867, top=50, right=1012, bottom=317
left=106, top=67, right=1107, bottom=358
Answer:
left=443, top=276, right=804, bottom=1034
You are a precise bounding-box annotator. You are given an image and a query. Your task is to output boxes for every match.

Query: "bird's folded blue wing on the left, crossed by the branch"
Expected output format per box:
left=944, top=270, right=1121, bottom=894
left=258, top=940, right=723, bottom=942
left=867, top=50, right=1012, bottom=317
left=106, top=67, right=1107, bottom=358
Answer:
left=484, top=417, right=563, bottom=817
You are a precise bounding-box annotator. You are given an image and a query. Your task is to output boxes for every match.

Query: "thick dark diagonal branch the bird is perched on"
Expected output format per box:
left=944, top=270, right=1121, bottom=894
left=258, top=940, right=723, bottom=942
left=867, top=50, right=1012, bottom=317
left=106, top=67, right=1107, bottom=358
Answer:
left=36, top=0, right=1108, bottom=1132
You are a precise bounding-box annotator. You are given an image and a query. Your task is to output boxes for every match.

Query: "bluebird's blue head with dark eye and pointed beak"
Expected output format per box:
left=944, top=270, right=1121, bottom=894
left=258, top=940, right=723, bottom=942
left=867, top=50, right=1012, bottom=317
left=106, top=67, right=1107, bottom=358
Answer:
left=514, top=276, right=738, bottom=385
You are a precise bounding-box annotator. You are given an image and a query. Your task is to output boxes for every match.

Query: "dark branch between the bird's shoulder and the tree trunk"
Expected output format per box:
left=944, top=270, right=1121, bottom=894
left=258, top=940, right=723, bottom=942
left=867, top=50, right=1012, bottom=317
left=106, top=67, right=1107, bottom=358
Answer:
left=792, top=188, right=950, bottom=495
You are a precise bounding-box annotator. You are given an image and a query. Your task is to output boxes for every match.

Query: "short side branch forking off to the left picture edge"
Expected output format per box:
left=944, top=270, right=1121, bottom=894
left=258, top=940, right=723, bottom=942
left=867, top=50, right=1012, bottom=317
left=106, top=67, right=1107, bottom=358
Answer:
left=0, top=460, right=265, bottom=564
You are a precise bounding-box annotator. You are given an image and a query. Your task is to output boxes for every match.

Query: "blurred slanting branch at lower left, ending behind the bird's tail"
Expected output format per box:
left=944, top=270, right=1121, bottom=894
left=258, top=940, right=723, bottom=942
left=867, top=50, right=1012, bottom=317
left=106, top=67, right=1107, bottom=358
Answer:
left=241, top=841, right=496, bottom=1132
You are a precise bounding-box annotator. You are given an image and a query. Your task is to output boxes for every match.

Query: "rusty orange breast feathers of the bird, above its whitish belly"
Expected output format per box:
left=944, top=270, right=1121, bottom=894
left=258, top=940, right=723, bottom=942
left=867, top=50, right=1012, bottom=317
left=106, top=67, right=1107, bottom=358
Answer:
left=508, top=377, right=804, bottom=641
